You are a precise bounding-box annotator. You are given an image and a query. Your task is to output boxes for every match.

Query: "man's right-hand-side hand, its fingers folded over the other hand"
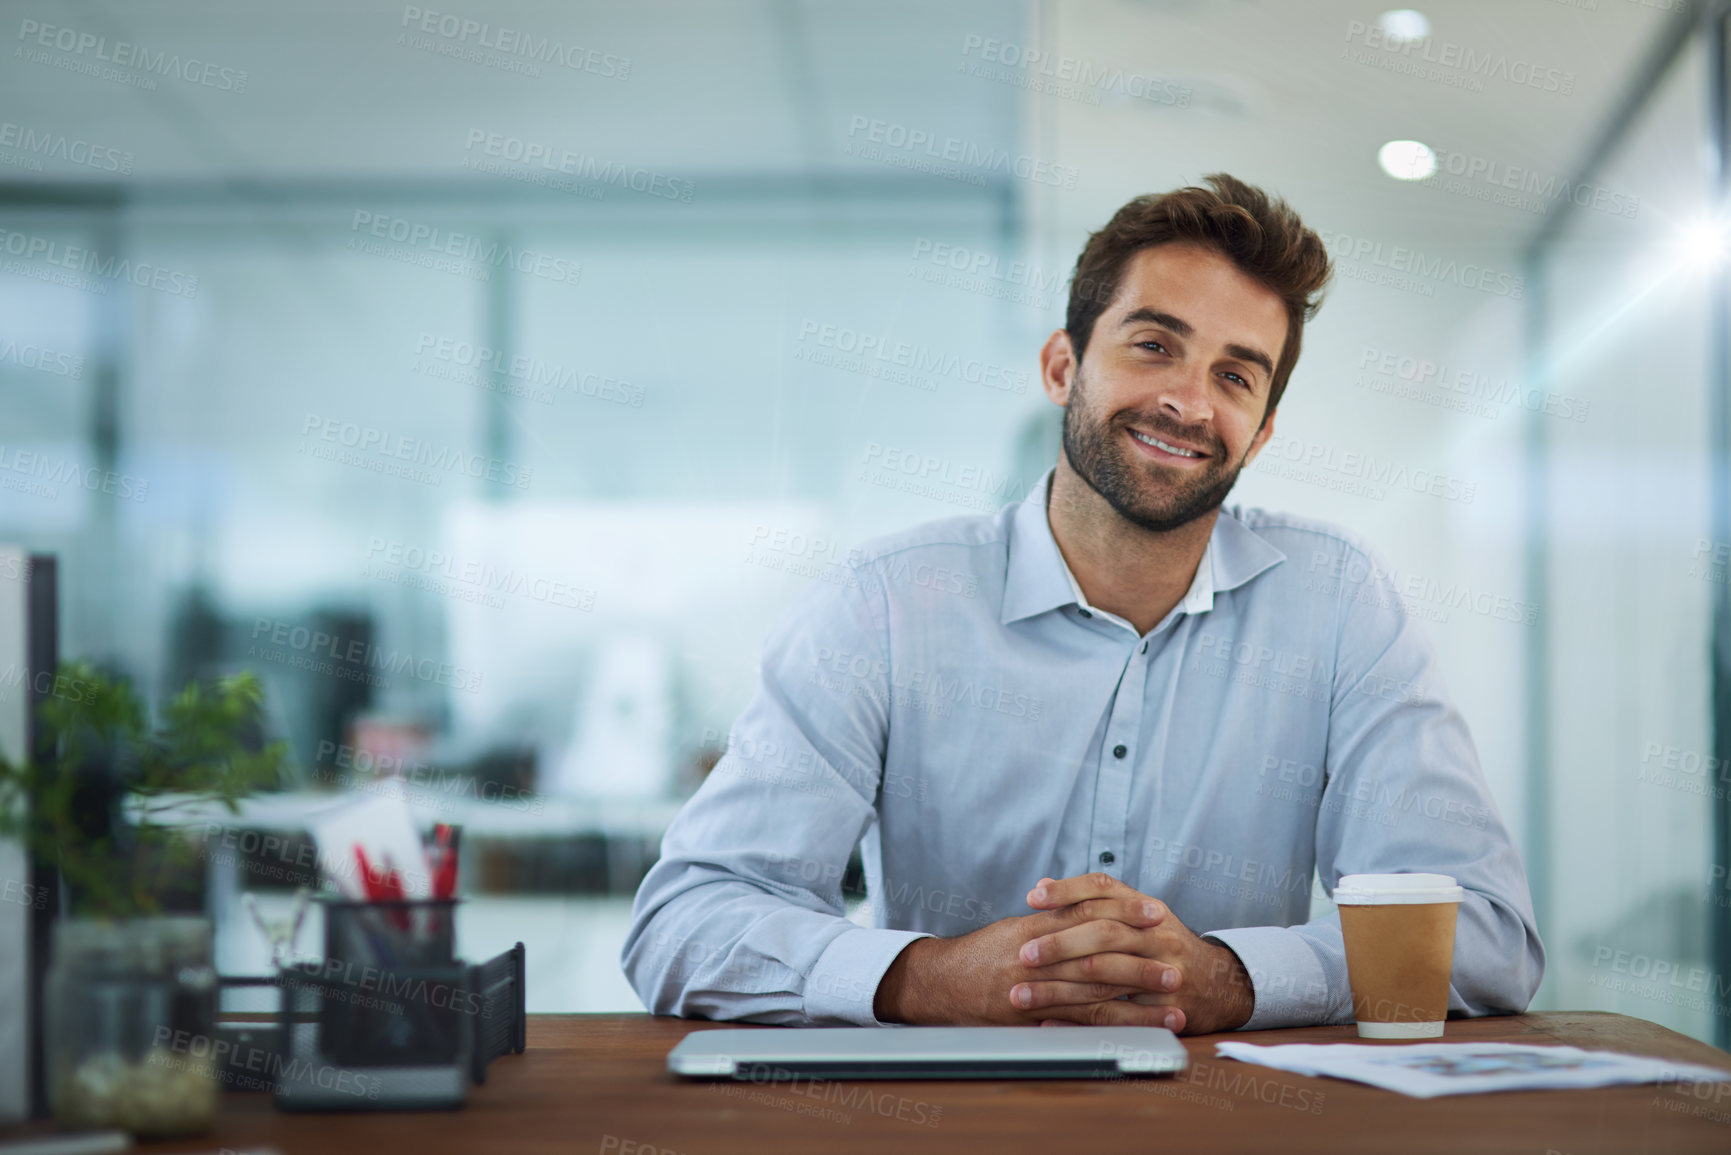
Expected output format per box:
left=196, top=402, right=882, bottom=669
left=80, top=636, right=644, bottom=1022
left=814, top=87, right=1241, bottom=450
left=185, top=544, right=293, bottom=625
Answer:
left=1009, top=874, right=1255, bottom=1034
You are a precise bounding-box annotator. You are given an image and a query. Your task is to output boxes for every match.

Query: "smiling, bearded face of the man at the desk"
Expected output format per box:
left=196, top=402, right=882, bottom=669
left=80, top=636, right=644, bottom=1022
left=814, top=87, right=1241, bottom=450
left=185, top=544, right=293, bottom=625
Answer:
left=1042, top=244, right=1286, bottom=532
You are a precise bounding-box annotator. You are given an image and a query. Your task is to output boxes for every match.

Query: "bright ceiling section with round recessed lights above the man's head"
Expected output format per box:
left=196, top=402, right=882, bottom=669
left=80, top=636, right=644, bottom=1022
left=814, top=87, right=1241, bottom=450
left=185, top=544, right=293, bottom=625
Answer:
left=1039, top=0, right=1683, bottom=251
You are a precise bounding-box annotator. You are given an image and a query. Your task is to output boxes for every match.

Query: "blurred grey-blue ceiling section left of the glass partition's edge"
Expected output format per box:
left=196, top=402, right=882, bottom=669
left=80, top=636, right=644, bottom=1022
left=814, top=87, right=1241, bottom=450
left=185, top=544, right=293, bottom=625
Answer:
left=0, top=0, right=1021, bottom=180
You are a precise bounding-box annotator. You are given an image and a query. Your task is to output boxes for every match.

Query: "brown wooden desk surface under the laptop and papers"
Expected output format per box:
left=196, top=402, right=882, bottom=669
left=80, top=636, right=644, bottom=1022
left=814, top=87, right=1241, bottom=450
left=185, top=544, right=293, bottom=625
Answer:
left=142, top=1011, right=1731, bottom=1155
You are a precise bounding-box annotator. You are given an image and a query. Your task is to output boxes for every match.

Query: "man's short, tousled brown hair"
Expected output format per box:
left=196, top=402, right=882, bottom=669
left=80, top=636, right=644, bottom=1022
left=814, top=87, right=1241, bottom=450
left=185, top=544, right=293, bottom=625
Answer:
left=1065, top=173, right=1335, bottom=414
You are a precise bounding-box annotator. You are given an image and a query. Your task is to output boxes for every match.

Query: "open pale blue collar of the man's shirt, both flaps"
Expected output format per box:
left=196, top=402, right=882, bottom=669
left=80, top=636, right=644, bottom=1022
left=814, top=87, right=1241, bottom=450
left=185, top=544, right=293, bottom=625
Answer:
left=999, top=466, right=1286, bottom=623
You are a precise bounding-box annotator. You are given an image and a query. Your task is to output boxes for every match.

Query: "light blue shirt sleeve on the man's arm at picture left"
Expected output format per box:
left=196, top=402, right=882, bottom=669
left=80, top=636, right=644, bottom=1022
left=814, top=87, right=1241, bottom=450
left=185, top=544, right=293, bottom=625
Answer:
left=621, top=566, right=924, bottom=1025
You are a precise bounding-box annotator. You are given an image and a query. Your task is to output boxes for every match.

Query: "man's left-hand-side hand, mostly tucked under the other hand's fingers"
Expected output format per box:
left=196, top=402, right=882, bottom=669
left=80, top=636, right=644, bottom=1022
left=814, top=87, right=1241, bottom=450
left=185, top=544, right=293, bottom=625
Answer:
left=872, top=892, right=1182, bottom=1027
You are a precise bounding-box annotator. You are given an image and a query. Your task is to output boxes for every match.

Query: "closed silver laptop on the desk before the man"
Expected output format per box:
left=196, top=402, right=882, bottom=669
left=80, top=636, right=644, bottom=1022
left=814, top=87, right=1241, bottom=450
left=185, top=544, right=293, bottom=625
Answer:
left=666, top=1027, right=1189, bottom=1082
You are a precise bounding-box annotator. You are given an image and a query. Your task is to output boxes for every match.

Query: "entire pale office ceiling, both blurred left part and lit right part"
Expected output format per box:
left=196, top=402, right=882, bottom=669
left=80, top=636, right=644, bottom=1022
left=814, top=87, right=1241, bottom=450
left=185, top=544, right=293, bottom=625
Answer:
left=0, top=0, right=1681, bottom=263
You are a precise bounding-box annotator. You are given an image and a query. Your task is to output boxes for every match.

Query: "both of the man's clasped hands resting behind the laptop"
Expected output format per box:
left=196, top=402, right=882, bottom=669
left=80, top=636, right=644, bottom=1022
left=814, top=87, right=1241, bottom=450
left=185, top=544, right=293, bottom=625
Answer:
left=874, top=873, right=1255, bottom=1034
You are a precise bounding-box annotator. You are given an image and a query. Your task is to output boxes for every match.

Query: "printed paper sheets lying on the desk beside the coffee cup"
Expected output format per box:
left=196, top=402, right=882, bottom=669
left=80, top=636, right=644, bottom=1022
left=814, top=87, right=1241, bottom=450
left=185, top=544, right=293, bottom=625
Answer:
left=1215, top=1042, right=1731, bottom=1100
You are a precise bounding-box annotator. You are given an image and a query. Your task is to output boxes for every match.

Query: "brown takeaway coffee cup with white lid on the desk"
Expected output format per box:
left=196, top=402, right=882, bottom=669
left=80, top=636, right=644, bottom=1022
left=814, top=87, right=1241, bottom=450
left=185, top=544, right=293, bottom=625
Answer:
left=1335, top=874, right=1464, bottom=1039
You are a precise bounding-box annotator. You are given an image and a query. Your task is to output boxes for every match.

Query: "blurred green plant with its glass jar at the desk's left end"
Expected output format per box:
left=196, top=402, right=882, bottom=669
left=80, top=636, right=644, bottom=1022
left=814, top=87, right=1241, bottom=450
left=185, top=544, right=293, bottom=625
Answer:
left=0, top=661, right=284, bottom=1136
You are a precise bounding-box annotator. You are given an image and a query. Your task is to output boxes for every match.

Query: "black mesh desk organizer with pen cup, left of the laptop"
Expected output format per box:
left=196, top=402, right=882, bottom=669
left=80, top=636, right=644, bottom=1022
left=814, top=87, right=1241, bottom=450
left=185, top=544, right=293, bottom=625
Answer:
left=275, top=899, right=524, bottom=1110
